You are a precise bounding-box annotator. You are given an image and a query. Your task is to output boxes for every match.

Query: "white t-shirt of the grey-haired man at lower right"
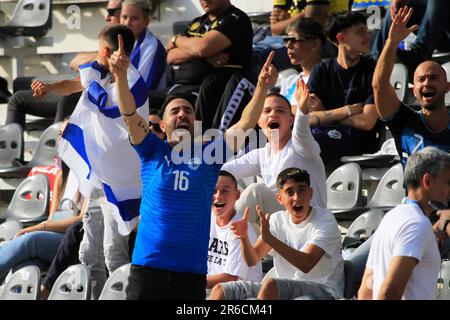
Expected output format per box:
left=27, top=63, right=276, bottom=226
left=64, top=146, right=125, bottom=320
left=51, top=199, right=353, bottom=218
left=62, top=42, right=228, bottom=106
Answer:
left=367, top=203, right=441, bottom=300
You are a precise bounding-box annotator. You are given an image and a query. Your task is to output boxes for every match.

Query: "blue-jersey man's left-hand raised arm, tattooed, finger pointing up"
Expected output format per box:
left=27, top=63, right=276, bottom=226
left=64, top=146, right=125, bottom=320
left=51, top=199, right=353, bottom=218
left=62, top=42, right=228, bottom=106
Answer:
left=108, top=35, right=150, bottom=144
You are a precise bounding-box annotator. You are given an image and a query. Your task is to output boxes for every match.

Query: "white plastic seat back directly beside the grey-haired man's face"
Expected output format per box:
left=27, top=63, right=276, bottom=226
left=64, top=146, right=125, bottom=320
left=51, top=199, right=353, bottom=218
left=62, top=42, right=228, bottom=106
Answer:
left=367, top=163, right=406, bottom=209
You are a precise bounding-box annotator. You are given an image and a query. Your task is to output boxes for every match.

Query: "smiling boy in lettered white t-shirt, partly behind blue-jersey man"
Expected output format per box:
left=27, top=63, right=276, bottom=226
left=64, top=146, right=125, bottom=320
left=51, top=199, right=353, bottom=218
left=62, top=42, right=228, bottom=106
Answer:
left=206, top=171, right=262, bottom=289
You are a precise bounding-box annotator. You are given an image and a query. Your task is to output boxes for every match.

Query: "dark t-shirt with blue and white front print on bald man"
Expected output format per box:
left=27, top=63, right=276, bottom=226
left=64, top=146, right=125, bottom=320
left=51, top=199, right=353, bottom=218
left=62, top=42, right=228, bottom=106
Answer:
left=383, top=103, right=450, bottom=166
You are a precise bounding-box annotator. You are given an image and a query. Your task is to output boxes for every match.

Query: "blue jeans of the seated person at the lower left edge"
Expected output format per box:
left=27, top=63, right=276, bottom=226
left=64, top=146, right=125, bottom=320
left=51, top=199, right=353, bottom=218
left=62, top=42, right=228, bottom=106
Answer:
left=0, top=231, right=64, bottom=282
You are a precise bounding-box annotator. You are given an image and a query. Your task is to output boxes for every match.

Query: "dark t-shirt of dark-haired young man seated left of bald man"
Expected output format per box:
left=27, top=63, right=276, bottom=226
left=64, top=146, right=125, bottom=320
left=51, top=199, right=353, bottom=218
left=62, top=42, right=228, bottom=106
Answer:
left=308, top=57, right=380, bottom=153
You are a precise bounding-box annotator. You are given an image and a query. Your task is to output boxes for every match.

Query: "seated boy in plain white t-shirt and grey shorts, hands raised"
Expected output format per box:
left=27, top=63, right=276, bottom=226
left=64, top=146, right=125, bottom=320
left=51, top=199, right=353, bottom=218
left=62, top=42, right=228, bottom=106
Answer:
left=210, top=168, right=344, bottom=300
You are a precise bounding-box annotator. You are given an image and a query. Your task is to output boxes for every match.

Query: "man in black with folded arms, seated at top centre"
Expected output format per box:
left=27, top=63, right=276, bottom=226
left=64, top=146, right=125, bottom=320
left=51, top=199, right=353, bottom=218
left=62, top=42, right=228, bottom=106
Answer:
left=167, top=0, right=254, bottom=129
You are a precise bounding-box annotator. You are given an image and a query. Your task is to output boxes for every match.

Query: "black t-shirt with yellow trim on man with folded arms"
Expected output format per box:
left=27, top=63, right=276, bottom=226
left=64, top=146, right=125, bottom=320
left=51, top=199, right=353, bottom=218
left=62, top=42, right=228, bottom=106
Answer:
left=175, top=6, right=253, bottom=85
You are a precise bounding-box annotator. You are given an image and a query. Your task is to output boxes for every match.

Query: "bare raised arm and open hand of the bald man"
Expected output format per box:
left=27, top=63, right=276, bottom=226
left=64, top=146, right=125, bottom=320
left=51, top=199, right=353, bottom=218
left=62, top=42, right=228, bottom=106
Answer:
left=372, top=6, right=418, bottom=118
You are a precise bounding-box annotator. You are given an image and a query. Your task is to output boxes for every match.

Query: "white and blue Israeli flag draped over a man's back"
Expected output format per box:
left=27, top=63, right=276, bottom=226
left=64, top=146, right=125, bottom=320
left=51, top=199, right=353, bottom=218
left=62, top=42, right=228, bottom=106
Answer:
left=59, top=62, right=148, bottom=235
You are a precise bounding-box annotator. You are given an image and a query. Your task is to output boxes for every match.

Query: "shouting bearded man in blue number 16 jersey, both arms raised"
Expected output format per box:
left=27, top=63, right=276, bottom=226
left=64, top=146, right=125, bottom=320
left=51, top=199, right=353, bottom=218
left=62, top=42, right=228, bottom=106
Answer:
left=110, top=36, right=277, bottom=300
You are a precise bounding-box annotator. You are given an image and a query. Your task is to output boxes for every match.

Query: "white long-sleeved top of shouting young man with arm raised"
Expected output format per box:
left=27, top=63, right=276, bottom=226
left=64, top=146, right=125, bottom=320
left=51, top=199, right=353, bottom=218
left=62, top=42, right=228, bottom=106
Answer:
left=222, top=110, right=327, bottom=208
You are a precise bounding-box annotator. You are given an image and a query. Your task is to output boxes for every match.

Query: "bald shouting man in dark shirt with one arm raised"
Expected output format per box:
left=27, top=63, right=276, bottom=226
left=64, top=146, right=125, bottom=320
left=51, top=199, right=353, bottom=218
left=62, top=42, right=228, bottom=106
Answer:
left=372, top=6, right=450, bottom=166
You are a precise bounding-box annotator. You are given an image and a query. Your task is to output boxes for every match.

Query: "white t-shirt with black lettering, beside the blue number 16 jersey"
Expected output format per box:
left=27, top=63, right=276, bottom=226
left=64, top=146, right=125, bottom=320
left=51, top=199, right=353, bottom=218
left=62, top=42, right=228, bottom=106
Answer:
left=208, top=213, right=262, bottom=282
